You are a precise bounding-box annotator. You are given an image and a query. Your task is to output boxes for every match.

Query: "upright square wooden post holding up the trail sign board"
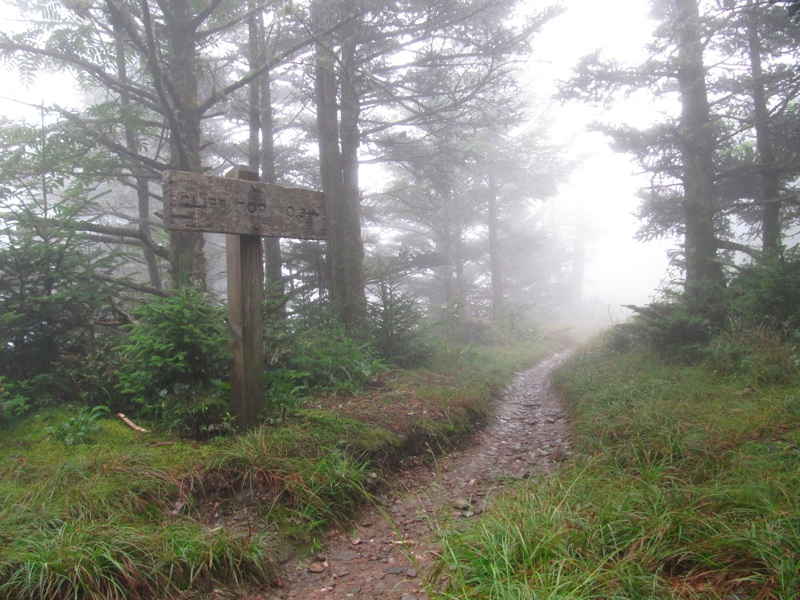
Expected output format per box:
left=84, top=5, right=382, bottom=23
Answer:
left=225, top=167, right=264, bottom=429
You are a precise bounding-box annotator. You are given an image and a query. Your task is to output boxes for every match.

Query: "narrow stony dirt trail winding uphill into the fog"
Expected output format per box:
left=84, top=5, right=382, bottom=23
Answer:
left=268, top=353, right=570, bottom=600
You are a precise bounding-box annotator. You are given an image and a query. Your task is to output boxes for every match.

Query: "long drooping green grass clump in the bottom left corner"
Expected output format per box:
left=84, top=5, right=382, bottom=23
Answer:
left=0, top=518, right=275, bottom=600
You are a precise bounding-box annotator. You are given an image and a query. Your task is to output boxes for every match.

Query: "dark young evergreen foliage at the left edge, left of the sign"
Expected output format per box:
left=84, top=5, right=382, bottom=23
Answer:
left=0, top=120, right=121, bottom=397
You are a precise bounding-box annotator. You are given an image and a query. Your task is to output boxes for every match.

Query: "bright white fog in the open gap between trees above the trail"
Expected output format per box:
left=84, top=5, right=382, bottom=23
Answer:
left=528, top=0, right=675, bottom=326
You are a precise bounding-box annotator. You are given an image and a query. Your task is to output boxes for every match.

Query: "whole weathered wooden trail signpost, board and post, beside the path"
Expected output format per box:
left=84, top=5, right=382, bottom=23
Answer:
left=164, top=167, right=327, bottom=429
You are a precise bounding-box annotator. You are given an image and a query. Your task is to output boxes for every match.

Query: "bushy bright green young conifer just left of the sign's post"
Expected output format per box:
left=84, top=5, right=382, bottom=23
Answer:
left=118, top=288, right=230, bottom=434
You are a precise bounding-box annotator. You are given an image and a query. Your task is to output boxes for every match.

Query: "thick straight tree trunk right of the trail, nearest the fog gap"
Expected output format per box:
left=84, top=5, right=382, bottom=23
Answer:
left=675, top=0, right=724, bottom=322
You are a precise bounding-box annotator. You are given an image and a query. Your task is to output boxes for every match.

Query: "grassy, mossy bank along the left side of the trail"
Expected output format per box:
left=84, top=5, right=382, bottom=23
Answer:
left=0, top=336, right=549, bottom=599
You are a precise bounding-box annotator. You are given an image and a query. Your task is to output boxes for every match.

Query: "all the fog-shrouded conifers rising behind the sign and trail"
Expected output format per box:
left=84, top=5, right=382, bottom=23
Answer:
left=0, top=0, right=800, bottom=420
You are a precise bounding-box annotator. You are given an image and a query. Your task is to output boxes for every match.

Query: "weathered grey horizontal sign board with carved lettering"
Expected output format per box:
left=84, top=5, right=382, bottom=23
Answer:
left=163, top=171, right=327, bottom=240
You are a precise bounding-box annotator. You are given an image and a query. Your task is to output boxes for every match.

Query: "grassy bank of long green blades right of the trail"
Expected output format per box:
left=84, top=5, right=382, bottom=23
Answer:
left=432, top=340, right=800, bottom=600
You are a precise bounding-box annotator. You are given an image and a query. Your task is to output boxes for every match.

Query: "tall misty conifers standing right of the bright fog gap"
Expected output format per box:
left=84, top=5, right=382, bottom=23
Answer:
left=561, top=0, right=798, bottom=324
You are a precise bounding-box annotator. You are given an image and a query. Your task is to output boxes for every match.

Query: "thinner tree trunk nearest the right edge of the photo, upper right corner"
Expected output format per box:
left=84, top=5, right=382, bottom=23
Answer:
left=746, top=7, right=781, bottom=254
